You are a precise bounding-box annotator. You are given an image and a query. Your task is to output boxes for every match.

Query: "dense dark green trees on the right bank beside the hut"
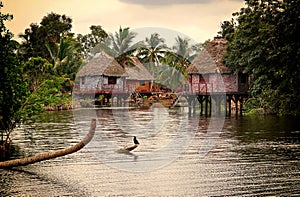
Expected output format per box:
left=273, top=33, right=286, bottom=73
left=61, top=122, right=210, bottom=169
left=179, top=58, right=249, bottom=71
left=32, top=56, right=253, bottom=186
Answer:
left=220, top=0, right=300, bottom=115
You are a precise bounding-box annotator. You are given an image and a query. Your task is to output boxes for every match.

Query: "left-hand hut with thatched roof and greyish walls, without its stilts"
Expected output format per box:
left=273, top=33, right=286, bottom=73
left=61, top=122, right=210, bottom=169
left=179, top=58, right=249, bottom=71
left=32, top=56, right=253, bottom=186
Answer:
left=77, top=53, right=125, bottom=94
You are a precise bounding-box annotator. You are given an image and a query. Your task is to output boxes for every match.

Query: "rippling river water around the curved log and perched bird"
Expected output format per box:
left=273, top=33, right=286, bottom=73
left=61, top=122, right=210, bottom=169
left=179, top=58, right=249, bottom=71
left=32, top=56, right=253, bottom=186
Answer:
left=0, top=108, right=300, bottom=196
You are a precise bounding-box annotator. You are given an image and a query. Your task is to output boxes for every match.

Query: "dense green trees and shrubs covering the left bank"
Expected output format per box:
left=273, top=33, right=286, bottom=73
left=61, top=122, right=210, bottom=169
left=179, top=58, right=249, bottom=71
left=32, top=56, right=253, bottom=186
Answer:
left=0, top=4, right=82, bottom=152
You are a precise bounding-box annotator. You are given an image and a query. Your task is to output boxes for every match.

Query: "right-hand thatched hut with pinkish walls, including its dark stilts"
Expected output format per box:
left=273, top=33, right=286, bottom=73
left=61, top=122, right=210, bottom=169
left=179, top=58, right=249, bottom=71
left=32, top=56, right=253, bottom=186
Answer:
left=186, top=37, right=248, bottom=115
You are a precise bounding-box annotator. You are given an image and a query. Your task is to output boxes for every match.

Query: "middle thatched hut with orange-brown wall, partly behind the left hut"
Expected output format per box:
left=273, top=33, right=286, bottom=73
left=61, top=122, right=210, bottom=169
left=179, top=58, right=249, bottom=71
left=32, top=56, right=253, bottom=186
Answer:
left=126, top=57, right=154, bottom=93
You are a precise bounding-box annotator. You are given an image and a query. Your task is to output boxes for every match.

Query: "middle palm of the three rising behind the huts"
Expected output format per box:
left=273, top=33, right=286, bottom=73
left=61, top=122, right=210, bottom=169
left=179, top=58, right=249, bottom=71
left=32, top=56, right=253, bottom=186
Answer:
left=138, top=33, right=168, bottom=77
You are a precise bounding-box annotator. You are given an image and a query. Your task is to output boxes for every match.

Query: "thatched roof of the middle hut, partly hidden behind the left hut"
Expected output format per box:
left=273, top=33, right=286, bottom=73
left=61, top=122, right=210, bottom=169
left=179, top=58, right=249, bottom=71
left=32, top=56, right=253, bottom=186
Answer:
left=126, top=57, right=154, bottom=81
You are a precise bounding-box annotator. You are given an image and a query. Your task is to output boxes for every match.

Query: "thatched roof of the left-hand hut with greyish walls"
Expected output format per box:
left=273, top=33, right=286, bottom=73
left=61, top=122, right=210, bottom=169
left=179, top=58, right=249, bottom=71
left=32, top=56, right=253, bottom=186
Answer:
left=77, top=52, right=126, bottom=77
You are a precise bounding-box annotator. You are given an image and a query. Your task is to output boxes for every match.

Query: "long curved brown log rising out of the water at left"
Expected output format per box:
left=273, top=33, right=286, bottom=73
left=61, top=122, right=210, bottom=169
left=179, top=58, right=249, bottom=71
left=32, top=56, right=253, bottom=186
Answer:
left=0, top=119, right=96, bottom=168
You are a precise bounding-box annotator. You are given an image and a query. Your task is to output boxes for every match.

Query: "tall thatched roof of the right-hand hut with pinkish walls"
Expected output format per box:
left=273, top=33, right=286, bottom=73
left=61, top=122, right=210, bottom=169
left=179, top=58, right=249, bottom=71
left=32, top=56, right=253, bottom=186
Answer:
left=186, top=38, right=231, bottom=74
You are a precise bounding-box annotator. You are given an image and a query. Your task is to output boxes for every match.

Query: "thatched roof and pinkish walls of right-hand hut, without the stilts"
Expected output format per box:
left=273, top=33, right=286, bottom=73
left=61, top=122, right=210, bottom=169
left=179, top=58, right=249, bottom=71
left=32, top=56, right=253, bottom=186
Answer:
left=187, top=38, right=248, bottom=94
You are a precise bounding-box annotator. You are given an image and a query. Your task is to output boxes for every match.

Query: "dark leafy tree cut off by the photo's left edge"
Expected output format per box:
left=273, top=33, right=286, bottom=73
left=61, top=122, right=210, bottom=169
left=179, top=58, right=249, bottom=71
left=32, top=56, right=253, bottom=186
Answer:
left=0, top=2, right=27, bottom=145
